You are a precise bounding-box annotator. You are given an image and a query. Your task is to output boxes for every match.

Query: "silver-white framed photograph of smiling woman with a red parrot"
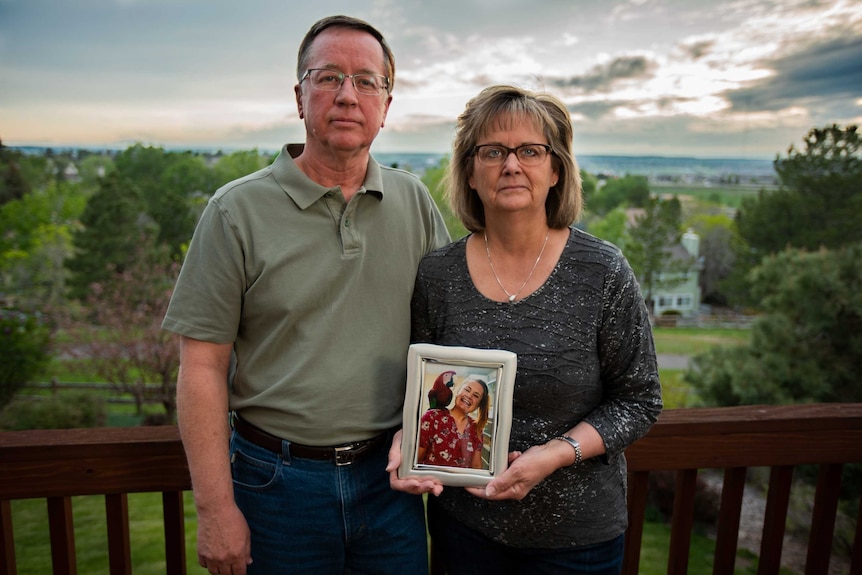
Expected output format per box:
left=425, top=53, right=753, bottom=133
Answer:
left=398, top=343, right=517, bottom=487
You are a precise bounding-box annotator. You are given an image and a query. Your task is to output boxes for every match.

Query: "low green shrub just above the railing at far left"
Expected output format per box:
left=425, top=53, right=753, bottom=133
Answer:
left=0, top=393, right=107, bottom=431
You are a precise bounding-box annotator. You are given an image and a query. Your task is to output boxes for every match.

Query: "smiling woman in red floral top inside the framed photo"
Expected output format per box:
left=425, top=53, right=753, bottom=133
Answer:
left=416, top=378, right=488, bottom=469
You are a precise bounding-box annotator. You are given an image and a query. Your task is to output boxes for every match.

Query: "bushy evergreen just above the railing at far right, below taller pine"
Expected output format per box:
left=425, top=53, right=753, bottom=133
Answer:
left=685, top=243, right=862, bottom=405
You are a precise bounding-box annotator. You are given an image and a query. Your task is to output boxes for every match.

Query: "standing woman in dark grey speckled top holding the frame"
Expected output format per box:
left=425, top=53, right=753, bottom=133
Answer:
left=388, top=86, right=662, bottom=575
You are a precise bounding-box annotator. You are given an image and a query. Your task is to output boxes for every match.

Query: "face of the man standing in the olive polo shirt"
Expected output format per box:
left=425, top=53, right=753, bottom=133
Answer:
left=294, top=28, right=392, bottom=153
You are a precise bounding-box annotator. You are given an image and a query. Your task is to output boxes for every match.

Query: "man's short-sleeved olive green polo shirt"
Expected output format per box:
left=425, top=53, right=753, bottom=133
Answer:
left=163, top=146, right=456, bottom=445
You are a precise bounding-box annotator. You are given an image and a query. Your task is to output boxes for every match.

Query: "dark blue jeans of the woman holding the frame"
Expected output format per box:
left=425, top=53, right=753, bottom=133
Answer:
left=428, top=498, right=625, bottom=575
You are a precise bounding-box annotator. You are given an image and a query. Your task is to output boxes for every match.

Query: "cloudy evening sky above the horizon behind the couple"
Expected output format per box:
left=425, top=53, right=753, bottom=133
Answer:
left=0, top=0, right=862, bottom=159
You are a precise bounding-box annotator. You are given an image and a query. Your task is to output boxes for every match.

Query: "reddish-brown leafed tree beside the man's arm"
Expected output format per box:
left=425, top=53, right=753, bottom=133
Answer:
left=64, top=241, right=179, bottom=421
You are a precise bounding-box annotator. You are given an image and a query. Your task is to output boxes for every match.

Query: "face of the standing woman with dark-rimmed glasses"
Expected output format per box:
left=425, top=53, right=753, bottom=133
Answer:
left=469, top=119, right=559, bottom=220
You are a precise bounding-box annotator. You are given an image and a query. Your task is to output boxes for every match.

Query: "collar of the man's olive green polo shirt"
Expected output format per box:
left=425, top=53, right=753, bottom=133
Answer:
left=272, top=144, right=383, bottom=210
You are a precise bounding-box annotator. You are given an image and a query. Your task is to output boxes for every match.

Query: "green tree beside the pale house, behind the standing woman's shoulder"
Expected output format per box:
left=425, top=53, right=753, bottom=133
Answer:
left=626, top=197, right=692, bottom=309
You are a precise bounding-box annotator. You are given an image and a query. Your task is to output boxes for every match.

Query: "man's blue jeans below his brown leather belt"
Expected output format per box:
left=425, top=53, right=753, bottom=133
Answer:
left=230, top=432, right=428, bottom=575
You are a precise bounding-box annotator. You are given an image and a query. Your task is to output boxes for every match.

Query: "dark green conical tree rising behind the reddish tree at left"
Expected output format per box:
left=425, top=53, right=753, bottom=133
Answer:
left=66, top=172, right=147, bottom=300
